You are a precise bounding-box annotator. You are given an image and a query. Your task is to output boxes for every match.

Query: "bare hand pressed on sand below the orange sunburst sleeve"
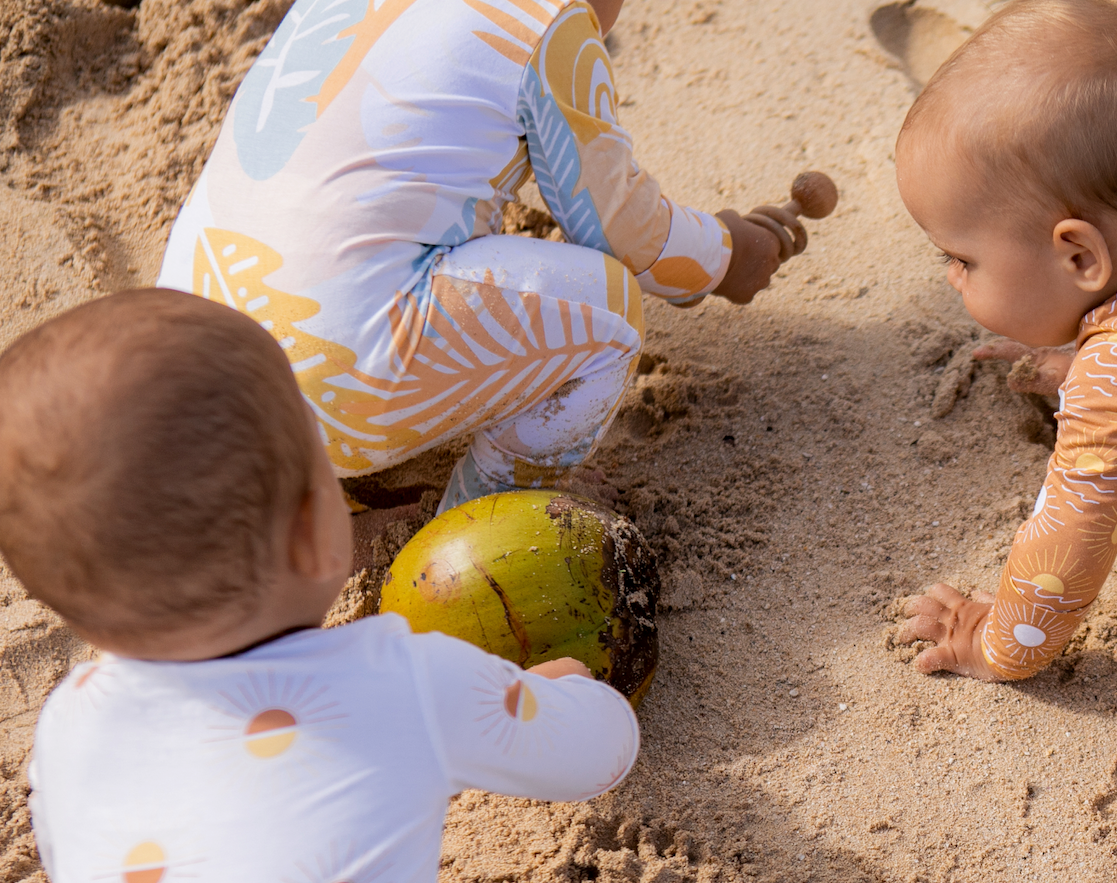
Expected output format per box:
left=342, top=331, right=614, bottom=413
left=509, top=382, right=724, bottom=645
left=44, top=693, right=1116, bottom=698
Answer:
left=896, top=583, right=1000, bottom=681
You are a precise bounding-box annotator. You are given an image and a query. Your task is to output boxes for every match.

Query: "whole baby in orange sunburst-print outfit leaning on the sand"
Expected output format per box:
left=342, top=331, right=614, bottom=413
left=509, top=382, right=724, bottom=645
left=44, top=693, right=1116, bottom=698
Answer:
left=896, top=0, right=1117, bottom=680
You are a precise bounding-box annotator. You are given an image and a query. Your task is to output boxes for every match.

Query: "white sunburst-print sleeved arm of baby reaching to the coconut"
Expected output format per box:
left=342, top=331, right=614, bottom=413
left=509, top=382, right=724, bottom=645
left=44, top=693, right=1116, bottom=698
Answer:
left=413, top=633, right=640, bottom=800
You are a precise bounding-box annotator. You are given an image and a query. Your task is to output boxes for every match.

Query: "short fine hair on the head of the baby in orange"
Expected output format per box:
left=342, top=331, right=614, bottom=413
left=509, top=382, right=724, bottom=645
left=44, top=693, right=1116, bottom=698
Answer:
left=900, top=0, right=1117, bottom=222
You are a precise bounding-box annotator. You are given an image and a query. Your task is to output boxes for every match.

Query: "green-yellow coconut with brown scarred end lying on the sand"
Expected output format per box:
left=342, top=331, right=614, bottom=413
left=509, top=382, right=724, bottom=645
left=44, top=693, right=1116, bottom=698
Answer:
left=380, top=490, right=659, bottom=706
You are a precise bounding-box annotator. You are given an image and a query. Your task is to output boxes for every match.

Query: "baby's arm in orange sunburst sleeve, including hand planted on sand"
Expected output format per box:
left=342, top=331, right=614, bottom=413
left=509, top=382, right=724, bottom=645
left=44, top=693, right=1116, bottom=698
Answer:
left=900, top=335, right=1117, bottom=680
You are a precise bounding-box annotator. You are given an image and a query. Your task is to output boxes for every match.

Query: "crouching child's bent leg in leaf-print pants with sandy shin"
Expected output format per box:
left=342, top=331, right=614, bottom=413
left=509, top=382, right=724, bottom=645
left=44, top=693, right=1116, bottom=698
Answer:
left=431, top=236, right=643, bottom=511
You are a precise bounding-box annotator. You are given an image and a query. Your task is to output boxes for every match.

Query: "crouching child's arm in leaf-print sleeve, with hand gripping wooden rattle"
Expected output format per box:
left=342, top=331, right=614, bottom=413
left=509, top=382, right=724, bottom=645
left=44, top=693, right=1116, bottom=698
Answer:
left=518, top=2, right=780, bottom=306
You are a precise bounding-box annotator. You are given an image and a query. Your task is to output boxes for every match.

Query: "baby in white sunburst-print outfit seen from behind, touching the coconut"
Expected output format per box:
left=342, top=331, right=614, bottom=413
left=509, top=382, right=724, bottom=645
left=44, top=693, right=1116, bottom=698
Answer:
left=0, top=290, right=639, bottom=883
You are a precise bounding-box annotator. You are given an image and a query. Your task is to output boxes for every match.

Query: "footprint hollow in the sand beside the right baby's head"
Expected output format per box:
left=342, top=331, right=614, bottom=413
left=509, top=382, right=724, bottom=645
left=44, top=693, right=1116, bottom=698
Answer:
left=869, top=0, right=971, bottom=86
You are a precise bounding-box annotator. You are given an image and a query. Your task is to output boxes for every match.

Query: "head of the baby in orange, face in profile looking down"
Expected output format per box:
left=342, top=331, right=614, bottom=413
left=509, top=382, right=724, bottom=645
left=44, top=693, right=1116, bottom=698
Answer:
left=896, top=0, right=1117, bottom=346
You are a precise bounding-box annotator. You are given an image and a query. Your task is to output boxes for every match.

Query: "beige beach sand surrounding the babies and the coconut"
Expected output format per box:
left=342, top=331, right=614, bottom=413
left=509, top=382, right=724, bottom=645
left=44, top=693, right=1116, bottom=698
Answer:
left=0, top=0, right=1117, bottom=883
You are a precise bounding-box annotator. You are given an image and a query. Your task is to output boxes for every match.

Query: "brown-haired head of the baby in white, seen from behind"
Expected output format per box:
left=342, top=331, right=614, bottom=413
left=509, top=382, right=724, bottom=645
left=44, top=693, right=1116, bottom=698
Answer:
left=0, top=289, right=350, bottom=660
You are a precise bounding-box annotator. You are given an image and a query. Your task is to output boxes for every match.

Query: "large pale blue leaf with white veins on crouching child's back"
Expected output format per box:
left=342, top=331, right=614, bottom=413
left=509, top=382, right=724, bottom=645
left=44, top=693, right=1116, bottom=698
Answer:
left=232, top=0, right=369, bottom=181
